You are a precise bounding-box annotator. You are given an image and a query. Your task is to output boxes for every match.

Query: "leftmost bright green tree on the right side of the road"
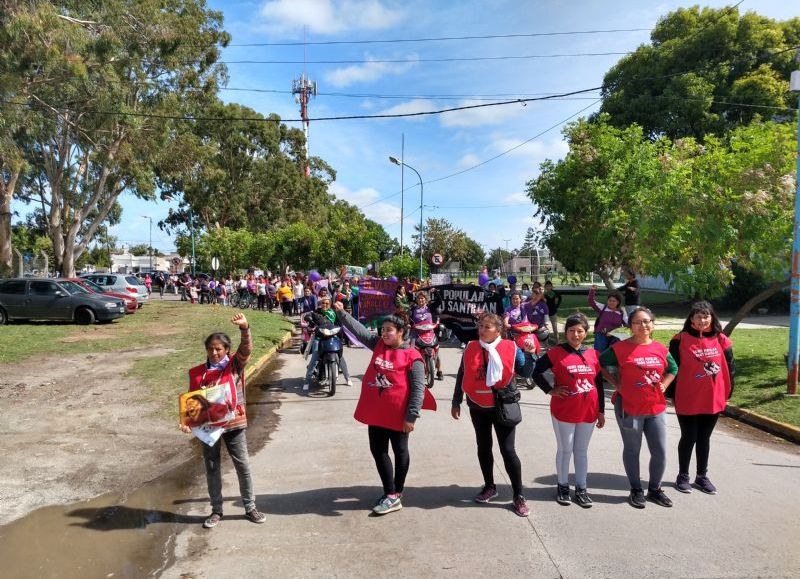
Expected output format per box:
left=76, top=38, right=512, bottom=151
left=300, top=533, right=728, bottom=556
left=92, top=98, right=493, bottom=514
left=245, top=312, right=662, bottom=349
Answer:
left=527, top=115, right=668, bottom=289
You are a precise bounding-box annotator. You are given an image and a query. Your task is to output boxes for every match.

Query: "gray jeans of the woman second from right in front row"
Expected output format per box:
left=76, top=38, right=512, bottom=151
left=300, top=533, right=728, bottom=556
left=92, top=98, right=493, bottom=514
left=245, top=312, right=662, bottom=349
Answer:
left=614, top=396, right=667, bottom=490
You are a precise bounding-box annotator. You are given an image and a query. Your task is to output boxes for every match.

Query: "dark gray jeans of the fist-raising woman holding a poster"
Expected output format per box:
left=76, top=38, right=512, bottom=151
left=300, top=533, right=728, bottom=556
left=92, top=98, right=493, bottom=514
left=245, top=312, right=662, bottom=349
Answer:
left=203, top=428, right=256, bottom=514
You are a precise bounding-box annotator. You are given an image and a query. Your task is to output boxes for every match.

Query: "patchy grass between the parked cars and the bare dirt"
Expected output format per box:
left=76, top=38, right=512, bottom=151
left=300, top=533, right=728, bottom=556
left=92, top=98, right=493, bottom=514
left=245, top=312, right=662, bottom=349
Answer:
left=0, top=300, right=291, bottom=415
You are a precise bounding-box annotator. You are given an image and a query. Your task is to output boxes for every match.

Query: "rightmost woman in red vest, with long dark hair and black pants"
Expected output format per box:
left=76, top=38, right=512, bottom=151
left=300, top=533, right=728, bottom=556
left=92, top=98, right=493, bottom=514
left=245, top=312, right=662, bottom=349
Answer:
left=669, top=301, right=735, bottom=495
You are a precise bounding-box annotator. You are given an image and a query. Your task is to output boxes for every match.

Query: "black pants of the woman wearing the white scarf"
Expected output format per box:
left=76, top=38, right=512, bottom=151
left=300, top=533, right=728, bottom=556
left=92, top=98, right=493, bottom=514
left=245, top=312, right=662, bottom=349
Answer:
left=469, top=408, right=522, bottom=497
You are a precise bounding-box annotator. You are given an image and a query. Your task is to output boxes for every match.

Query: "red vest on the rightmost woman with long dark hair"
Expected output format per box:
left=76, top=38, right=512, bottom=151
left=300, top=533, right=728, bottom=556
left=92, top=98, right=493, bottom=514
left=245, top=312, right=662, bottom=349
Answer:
left=673, top=332, right=731, bottom=414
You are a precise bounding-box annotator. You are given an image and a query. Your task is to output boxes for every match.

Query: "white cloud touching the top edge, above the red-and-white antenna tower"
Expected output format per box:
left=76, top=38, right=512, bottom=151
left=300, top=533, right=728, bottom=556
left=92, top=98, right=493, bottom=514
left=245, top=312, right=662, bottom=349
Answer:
left=259, top=0, right=405, bottom=35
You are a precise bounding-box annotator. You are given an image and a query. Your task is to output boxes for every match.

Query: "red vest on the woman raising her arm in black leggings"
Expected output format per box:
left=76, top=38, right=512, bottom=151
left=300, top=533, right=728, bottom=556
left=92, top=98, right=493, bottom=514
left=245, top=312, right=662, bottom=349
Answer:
left=353, top=340, right=436, bottom=431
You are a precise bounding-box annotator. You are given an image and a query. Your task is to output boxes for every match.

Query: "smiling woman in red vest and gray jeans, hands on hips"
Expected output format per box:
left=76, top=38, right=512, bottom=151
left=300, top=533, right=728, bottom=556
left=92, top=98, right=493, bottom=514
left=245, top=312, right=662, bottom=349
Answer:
left=600, top=308, right=678, bottom=509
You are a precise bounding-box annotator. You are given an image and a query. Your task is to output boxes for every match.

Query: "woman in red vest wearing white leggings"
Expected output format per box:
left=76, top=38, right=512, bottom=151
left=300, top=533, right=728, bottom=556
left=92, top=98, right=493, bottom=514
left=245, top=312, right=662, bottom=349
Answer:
left=533, top=313, right=606, bottom=508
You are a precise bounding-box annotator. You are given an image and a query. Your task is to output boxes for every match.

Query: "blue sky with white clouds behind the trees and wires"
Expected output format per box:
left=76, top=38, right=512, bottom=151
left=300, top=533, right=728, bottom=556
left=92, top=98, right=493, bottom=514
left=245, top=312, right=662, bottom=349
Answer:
left=15, top=0, right=800, bottom=259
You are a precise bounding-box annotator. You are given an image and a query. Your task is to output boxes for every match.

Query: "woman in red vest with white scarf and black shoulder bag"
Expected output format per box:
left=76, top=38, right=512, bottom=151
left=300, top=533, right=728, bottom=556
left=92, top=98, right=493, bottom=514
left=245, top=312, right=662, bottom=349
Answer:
left=450, top=314, right=535, bottom=517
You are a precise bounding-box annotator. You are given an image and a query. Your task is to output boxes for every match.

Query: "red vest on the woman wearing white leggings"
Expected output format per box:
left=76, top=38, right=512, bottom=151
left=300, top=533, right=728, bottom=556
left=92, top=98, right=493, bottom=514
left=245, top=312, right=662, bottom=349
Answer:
left=545, top=346, right=600, bottom=423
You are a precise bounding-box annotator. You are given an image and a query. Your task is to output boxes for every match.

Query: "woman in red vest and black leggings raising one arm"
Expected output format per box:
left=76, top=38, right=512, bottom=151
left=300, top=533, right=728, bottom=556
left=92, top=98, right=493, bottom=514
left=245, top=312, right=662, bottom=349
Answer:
left=333, top=302, right=436, bottom=515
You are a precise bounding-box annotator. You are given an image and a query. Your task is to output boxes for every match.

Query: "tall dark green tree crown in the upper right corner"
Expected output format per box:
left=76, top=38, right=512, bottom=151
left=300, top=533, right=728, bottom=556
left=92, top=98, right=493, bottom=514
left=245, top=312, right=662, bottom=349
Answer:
left=600, top=6, right=800, bottom=139
